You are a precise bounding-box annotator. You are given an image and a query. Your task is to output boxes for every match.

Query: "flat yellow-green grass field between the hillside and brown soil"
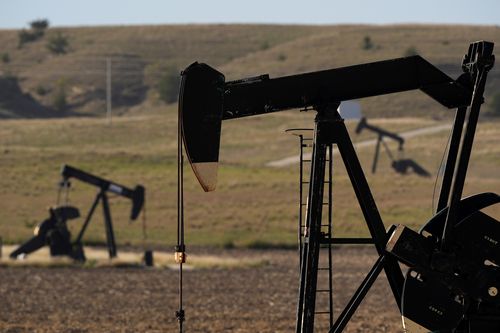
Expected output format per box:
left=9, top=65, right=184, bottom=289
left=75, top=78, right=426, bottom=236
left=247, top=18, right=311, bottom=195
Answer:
left=0, top=108, right=500, bottom=247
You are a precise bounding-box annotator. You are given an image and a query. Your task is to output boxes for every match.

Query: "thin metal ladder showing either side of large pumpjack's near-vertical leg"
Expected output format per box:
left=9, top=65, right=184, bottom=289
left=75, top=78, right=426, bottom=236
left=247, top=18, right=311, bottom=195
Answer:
left=287, top=129, right=334, bottom=327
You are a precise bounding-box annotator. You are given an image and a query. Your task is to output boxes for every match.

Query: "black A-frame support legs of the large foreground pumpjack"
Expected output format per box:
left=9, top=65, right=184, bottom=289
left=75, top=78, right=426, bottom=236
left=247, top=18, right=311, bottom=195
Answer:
left=296, top=105, right=404, bottom=333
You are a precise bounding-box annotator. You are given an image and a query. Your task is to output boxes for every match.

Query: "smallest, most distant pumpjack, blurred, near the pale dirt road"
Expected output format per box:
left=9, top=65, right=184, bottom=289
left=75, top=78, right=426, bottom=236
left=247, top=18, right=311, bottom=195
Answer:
left=356, top=117, right=431, bottom=177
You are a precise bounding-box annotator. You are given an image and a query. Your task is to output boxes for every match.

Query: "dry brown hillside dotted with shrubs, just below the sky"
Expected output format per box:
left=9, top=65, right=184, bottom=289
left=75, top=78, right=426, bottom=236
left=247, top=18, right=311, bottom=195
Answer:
left=0, top=25, right=500, bottom=118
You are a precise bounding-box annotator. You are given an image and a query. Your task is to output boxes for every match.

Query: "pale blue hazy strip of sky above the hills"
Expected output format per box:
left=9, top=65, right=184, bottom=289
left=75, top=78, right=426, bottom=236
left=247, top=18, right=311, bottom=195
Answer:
left=0, top=0, right=500, bottom=28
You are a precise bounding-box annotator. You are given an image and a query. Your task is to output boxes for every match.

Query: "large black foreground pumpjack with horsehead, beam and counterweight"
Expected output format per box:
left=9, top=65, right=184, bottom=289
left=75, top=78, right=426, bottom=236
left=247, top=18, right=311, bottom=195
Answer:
left=177, top=41, right=500, bottom=333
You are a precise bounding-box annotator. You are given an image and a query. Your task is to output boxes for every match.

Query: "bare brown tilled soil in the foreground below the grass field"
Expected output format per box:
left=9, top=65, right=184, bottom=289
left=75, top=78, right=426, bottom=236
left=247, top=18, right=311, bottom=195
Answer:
left=0, top=247, right=402, bottom=333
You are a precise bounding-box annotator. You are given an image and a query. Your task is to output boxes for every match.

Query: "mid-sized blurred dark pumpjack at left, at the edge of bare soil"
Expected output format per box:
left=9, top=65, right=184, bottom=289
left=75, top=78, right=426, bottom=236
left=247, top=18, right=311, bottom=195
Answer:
left=10, top=165, right=145, bottom=261
